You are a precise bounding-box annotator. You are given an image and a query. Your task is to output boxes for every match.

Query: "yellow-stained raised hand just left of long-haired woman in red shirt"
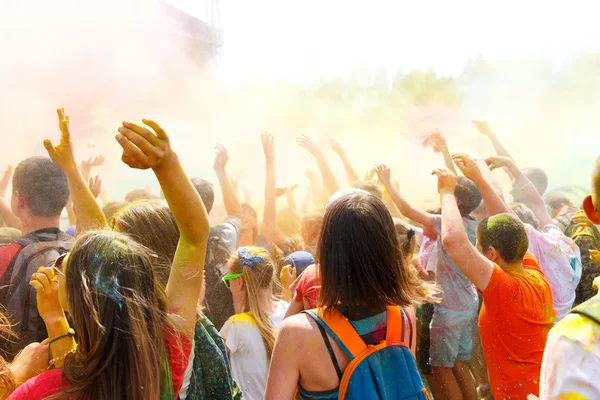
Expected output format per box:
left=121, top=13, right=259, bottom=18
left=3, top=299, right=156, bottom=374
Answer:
left=29, top=267, right=64, bottom=324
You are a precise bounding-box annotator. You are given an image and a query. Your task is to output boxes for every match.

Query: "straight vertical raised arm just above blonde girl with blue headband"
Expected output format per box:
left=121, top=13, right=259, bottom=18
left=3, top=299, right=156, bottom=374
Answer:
left=261, top=133, right=277, bottom=244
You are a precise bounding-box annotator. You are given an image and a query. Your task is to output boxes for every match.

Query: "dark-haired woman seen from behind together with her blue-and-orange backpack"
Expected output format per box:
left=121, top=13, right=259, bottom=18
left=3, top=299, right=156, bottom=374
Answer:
left=265, top=190, right=434, bottom=400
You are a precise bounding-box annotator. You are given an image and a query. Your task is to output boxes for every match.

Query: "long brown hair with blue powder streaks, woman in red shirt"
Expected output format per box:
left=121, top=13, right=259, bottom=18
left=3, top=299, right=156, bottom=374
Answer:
left=51, top=232, right=168, bottom=400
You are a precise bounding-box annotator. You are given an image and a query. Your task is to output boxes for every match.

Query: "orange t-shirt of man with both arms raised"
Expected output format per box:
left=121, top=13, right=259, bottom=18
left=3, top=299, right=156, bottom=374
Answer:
left=479, top=253, right=556, bottom=398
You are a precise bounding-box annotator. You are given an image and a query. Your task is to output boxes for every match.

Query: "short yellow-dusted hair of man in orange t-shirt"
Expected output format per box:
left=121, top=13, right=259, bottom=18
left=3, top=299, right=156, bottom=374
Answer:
left=477, top=214, right=529, bottom=263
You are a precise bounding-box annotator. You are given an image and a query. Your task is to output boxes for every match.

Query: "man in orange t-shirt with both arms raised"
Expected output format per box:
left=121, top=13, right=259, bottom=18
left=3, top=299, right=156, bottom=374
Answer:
left=435, top=155, right=556, bottom=399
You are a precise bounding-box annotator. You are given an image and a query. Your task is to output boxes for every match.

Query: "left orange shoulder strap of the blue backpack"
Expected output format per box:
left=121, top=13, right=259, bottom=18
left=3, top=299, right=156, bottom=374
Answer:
left=306, top=308, right=367, bottom=360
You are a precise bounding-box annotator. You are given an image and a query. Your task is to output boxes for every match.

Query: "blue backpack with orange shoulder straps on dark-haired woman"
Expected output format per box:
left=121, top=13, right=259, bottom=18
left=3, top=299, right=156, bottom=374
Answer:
left=307, top=306, right=429, bottom=400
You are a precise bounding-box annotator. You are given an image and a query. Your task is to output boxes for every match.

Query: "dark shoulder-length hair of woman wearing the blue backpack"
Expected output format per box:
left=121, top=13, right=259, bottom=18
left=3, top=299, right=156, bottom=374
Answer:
left=317, top=193, right=433, bottom=310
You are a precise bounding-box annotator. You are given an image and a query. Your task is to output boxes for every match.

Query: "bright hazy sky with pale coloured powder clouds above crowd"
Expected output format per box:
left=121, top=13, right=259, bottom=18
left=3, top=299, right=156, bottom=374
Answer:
left=0, top=0, right=600, bottom=222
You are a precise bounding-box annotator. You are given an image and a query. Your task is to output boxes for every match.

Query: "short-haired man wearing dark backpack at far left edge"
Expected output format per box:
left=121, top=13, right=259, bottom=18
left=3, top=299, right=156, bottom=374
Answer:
left=0, top=157, right=73, bottom=358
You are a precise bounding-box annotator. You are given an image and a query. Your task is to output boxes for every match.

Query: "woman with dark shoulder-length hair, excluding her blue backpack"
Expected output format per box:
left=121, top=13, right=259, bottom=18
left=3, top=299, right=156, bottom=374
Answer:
left=265, top=190, right=437, bottom=400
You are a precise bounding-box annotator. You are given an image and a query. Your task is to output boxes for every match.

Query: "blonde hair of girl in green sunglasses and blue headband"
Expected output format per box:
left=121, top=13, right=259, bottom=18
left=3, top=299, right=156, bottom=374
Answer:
left=229, top=246, right=277, bottom=360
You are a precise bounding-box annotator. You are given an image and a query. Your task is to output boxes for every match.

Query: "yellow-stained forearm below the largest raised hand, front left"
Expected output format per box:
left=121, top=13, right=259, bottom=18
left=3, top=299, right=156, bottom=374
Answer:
left=153, top=153, right=210, bottom=246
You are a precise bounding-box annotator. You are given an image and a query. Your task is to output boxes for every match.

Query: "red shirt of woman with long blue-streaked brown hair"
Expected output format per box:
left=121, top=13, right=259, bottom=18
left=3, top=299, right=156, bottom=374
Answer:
left=9, top=327, right=192, bottom=400
